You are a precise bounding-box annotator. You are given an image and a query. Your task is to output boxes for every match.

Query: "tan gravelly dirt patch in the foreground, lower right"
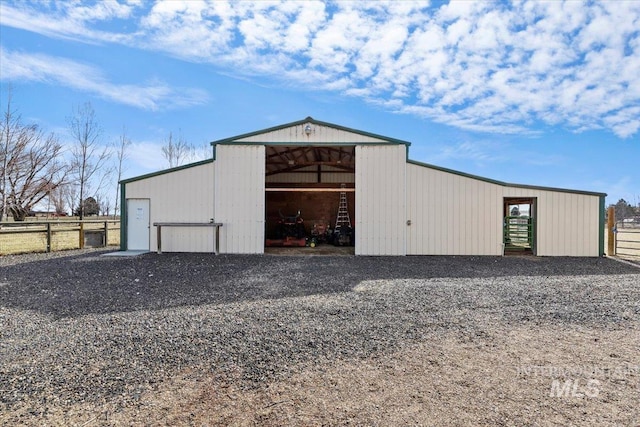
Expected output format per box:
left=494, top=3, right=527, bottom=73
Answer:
left=99, top=326, right=640, bottom=426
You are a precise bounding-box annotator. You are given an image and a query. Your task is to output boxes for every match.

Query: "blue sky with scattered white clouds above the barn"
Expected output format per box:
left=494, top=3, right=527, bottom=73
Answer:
left=0, top=0, right=640, bottom=211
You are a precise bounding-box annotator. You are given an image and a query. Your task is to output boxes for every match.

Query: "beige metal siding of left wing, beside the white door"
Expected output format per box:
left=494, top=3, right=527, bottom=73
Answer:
left=125, top=163, right=215, bottom=252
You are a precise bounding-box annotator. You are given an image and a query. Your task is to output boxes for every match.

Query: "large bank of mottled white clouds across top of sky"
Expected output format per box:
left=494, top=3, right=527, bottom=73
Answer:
left=0, top=0, right=640, bottom=138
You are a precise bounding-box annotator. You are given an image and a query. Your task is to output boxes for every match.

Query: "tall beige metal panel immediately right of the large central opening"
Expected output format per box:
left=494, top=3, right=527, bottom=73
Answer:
left=355, top=145, right=407, bottom=255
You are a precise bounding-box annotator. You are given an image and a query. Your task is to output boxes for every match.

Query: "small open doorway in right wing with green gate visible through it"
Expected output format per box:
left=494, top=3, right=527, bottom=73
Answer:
left=503, top=197, right=536, bottom=255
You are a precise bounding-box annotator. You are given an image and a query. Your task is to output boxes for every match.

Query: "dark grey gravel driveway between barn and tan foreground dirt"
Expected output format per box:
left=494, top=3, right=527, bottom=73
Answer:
left=0, top=251, right=640, bottom=425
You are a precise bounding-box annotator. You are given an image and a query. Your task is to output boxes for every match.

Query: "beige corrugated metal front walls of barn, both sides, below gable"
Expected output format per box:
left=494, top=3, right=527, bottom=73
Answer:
left=126, top=145, right=600, bottom=256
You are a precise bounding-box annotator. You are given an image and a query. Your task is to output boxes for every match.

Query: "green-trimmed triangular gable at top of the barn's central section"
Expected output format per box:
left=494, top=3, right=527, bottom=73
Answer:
left=211, top=117, right=411, bottom=146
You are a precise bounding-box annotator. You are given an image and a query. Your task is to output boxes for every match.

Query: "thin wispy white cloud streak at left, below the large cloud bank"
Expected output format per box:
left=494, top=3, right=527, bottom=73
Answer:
left=0, top=47, right=208, bottom=111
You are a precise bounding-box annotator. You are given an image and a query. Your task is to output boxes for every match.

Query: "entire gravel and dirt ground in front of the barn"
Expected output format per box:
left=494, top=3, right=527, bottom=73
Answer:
left=0, top=254, right=640, bottom=426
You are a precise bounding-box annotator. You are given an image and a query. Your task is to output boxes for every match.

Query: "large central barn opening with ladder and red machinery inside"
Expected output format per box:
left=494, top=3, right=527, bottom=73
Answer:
left=265, top=145, right=356, bottom=255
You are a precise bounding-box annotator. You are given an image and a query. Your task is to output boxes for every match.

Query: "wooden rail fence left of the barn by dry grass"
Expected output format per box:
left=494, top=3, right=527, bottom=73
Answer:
left=0, top=219, right=120, bottom=255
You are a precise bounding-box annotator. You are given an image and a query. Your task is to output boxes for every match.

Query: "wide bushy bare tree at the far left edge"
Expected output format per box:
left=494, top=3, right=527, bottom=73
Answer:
left=0, top=96, right=67, bottom=221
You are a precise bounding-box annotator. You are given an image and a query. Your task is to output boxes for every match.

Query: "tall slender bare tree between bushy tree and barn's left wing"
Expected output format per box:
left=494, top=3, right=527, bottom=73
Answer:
left=68, top=102, right=111, bottom=219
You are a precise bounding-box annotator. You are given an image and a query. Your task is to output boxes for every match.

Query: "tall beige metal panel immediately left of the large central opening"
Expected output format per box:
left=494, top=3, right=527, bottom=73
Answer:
left=215, top=145, right=265, bottom=253
